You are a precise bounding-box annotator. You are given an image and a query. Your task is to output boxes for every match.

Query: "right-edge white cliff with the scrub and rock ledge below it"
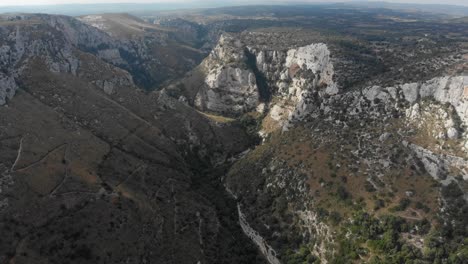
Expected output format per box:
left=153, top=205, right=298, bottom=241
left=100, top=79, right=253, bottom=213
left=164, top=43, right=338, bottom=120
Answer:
left=330, top=76, right=468, bottom=185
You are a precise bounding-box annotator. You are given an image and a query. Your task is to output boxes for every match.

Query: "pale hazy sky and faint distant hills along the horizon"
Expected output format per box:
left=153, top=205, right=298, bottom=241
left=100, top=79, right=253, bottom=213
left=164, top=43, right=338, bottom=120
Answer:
left=0, top=0, right=468, bottom=17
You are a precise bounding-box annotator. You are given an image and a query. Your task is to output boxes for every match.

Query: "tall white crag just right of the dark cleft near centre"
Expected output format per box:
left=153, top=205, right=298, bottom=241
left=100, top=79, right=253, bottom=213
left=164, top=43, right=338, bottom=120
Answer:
left=250, top=43, right=339, bottom=132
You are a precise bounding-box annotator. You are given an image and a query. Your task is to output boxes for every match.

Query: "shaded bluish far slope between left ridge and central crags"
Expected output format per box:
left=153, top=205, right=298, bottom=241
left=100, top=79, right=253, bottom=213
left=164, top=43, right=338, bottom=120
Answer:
left=78, top=14, right=206, bottom=90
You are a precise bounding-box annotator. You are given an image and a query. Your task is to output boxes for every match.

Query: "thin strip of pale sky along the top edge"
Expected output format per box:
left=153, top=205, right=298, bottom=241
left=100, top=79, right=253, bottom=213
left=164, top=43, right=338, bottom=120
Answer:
left=0, top=0, right=468, bottom=6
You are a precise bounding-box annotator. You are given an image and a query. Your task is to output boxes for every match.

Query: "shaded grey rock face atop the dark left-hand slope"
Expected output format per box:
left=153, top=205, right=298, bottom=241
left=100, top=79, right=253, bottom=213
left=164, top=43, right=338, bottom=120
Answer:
left=0, top=15, right=137, bottom=104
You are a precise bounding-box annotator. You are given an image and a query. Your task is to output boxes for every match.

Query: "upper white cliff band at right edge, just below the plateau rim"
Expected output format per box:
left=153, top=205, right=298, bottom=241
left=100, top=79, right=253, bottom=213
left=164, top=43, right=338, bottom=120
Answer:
left=354, top=76, right=468, bottom=151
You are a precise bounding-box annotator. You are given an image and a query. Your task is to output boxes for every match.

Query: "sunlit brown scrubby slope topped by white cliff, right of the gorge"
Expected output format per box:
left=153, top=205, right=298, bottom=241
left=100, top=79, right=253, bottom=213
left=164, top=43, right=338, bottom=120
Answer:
left=227, top=76, right=468, bottom=263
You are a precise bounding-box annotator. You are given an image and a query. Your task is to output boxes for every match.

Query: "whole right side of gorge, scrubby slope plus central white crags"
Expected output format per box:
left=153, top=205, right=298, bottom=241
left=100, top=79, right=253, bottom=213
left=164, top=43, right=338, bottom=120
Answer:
left=172, top=32, right=468, bottom=263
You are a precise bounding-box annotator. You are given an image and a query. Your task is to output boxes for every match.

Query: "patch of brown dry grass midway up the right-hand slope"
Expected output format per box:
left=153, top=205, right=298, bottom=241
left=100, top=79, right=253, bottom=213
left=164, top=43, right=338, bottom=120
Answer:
left=264, top=126, right=439, bottom=223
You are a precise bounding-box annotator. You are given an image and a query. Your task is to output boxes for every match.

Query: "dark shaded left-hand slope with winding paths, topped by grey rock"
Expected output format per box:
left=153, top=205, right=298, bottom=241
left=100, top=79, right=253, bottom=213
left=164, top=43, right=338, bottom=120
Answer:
left=0, top=15, right=261, bottom=263
